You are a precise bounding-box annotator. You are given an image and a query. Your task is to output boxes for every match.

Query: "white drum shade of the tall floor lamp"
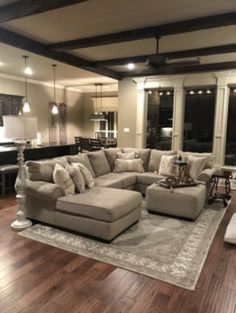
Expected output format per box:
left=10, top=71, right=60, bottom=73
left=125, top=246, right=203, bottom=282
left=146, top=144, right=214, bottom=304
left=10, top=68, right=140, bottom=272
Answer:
left=3, top=115, right=38, bottom=140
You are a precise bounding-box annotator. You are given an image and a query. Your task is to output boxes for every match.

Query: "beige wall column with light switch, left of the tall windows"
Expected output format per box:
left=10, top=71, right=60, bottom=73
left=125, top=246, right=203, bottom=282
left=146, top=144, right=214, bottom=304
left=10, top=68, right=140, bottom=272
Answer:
left=118, top=79, right=137, bottom=147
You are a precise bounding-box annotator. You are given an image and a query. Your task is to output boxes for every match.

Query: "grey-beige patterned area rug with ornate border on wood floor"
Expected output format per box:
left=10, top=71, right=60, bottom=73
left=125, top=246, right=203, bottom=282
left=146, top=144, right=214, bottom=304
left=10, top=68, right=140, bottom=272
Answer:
left=20, top=202, right=230, bottom=290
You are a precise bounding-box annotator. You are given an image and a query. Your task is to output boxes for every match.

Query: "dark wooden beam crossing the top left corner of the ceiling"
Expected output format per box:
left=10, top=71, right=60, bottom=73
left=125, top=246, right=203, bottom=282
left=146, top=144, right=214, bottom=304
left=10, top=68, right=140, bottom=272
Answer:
left=0, top=0, right=88, bottom=23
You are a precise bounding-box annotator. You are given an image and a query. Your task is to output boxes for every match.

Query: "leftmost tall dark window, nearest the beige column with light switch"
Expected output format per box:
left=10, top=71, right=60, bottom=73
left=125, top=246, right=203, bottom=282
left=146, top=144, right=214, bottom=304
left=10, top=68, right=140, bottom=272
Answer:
left=146, top=89, right=173, bottom=150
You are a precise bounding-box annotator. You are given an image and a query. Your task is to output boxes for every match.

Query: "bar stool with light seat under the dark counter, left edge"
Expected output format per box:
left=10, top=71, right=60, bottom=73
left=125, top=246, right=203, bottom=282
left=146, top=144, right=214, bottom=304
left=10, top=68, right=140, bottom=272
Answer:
left=0, top=164, right=19, bottom=197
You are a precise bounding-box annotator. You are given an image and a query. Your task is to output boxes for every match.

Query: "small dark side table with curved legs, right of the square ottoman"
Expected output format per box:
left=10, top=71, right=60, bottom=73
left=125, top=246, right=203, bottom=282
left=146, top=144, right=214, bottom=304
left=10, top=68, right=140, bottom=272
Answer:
left=208, top=170, right=233, bottom=207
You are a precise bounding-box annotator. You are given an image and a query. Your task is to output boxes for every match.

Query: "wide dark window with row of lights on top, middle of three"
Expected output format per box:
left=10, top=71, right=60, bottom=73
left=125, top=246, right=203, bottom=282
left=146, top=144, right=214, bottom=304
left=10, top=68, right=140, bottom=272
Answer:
left=183, top=88, right=216, bottom=152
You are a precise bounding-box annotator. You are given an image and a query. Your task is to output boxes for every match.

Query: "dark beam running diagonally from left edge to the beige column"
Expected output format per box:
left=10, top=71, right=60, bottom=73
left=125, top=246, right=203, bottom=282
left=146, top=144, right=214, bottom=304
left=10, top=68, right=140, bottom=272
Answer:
left=0, top=28, right=121, bottom=80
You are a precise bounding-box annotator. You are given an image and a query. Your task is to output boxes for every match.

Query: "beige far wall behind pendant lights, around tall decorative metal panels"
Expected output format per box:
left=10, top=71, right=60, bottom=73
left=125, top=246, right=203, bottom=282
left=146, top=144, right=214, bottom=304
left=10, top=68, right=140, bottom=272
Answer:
left=0, top=77, right=83, bottom=143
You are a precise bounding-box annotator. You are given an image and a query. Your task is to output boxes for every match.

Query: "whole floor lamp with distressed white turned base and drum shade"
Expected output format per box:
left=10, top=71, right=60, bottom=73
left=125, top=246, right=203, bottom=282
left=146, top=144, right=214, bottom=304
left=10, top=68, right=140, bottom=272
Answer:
left=3, top=115, right=37, bottom=230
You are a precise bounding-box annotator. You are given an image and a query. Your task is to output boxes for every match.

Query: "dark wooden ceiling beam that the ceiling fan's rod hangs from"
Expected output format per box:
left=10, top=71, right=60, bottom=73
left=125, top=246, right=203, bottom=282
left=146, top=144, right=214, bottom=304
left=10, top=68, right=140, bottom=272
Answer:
left=49, top=12, right=236, bottom=51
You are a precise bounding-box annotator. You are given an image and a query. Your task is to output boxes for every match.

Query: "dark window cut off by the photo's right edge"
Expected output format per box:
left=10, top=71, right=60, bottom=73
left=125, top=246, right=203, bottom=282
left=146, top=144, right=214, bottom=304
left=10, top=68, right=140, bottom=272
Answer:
left=225, top=88, right=236, bottom=166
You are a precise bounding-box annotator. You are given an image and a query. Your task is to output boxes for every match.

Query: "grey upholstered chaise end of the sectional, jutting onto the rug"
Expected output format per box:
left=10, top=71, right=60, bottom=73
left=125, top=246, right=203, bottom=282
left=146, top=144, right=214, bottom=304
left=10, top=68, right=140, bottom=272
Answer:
left=54, top=187, right=142, bottom=241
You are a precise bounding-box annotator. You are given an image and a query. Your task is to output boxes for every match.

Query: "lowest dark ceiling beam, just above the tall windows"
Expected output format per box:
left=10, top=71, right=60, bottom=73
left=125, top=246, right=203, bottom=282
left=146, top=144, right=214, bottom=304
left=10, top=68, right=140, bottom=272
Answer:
left=121, top=61, right=236, bottom=77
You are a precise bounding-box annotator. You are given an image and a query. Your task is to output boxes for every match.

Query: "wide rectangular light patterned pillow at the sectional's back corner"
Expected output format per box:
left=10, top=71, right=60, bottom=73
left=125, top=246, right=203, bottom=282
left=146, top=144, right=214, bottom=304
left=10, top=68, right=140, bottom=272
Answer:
left=114, top=159, right=144, bottom=173
